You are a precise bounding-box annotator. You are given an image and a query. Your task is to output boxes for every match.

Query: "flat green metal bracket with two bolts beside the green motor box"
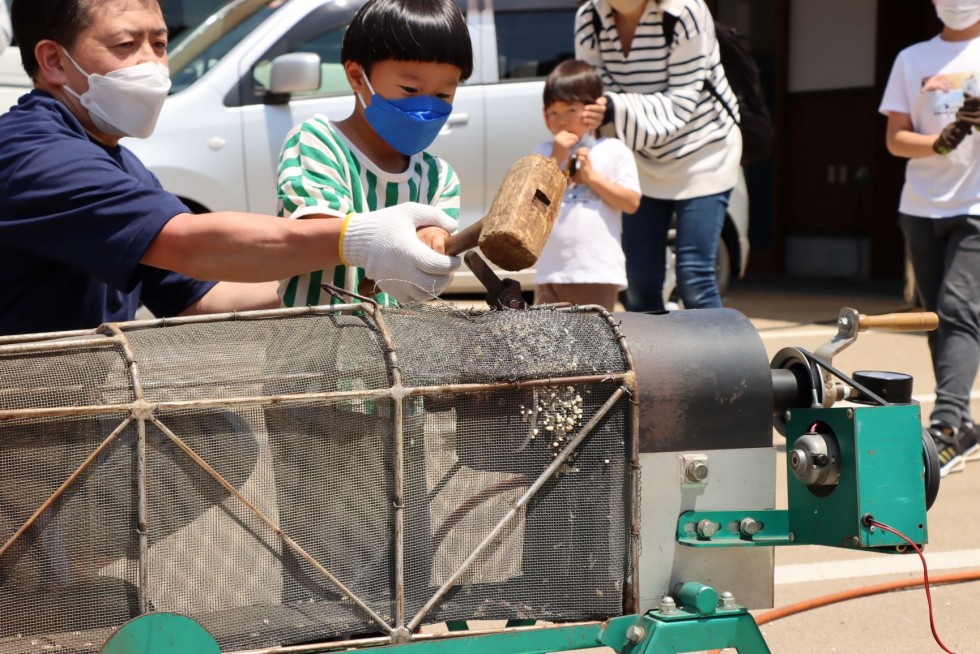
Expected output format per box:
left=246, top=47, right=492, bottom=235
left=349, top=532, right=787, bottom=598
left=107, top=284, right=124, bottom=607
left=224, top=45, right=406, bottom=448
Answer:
left=677, top=510, right=795, bottom=547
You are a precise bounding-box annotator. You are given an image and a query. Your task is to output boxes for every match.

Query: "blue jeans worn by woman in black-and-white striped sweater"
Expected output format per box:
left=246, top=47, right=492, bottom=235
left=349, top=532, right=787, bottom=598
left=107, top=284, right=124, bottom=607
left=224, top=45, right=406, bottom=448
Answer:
left=623, top=191, right=732, bottom=311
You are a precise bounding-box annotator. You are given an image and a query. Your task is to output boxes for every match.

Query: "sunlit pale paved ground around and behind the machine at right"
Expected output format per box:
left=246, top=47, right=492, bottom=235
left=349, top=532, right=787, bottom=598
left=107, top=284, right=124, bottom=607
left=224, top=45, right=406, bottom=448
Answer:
left=438, top=277, right=980, bottom=654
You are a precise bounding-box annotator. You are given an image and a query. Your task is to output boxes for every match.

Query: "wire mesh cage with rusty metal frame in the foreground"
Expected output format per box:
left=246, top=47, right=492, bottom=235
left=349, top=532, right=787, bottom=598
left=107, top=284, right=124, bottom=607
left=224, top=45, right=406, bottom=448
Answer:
left=0, top=305, right=635, bottom=654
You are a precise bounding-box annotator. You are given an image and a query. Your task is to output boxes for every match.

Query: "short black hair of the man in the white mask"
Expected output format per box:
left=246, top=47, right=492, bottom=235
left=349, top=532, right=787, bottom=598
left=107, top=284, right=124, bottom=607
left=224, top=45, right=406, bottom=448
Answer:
left=11, top=0, right=160, bottom=78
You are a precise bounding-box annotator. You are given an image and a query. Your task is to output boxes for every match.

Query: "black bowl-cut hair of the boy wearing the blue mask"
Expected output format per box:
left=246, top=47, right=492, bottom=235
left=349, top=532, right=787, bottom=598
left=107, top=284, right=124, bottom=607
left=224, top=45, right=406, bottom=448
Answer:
left=338, top=0, right=473, bottom=80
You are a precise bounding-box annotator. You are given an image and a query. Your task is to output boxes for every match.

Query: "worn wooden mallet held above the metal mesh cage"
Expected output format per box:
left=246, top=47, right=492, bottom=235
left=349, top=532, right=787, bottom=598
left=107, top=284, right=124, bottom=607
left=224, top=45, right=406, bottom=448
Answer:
left=446, top=154, right=568, bottom=271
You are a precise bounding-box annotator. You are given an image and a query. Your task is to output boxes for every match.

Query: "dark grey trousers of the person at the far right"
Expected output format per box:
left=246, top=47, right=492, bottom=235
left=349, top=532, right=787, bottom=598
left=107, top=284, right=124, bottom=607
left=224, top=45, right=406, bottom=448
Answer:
left=899, top=215, right=980, bottom=427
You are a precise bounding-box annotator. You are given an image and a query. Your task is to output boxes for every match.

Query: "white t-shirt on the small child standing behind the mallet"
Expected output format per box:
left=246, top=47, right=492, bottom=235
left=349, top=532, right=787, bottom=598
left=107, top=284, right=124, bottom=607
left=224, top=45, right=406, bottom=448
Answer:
left=534, top=138, right=640, bottom=289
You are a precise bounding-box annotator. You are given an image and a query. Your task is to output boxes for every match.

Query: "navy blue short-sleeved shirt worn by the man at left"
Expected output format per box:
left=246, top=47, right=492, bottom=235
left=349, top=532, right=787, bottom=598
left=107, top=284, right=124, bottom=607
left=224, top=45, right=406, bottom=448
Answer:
left=0, top=92, right=215, bottom=334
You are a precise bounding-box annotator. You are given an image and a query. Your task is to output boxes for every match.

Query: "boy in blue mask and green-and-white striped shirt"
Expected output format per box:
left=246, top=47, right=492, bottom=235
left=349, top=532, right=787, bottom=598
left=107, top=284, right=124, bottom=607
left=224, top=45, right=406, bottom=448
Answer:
left=278, top=0, right=473, bottom=306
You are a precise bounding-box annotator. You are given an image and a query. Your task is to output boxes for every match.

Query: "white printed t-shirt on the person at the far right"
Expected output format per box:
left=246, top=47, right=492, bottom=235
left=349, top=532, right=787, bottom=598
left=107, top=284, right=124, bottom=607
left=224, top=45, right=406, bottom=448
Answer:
left=879, top=36, right=980, bottom=218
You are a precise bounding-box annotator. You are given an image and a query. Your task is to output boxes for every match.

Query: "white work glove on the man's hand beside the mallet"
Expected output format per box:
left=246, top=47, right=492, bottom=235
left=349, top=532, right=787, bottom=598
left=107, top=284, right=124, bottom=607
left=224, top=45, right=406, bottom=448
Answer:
left=340, top=202, right=460, bottom=302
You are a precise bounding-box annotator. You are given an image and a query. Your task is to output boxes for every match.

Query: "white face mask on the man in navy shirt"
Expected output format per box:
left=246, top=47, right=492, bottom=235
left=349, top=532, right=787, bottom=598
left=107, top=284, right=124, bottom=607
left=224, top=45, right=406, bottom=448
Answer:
left=65, top=50, right=170, bottom=139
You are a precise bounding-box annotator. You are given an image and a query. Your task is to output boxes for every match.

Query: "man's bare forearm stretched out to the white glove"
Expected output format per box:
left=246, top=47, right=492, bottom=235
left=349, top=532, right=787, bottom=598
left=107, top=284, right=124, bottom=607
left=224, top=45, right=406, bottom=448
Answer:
left=140, top=211, right=343, bottom=280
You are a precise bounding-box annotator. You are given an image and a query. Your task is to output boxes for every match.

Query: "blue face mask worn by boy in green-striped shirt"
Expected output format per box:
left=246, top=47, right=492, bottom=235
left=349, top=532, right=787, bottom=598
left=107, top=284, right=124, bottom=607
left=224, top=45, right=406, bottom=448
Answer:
left=357, top=75, right=453, bottom=156
